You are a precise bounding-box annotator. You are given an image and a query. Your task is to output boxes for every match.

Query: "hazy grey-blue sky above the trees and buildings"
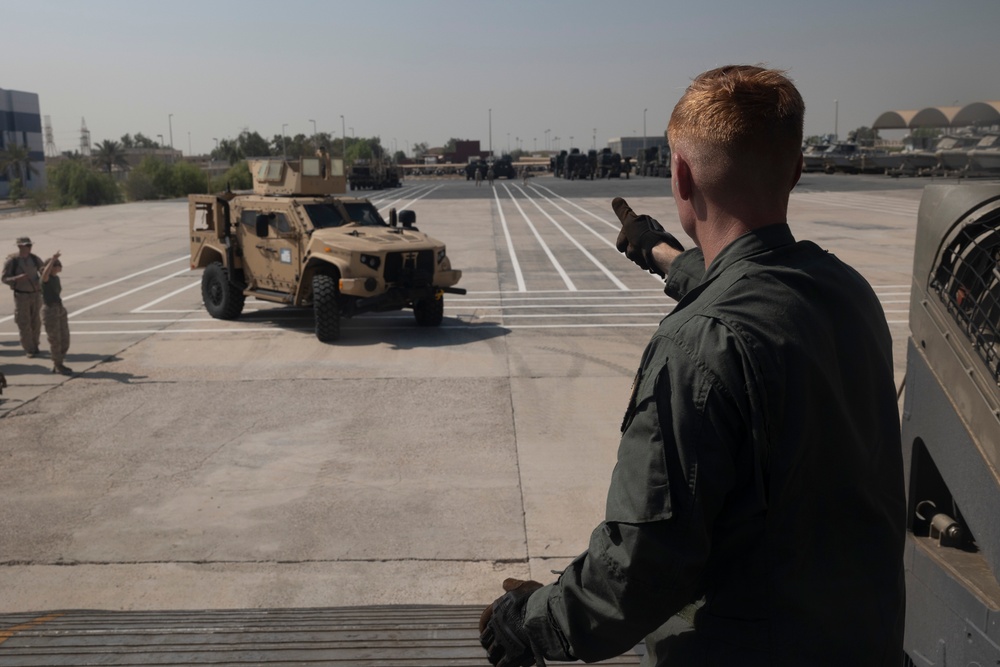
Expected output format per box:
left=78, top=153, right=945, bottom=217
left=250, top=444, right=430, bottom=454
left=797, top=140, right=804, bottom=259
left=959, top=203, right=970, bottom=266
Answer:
left=7, top=0, right=1000, bottom=158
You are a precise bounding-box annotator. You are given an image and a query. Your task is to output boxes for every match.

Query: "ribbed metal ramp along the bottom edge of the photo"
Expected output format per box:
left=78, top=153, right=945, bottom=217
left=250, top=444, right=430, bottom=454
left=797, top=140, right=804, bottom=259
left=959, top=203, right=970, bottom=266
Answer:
left=0, top=606, right=639, bottom=667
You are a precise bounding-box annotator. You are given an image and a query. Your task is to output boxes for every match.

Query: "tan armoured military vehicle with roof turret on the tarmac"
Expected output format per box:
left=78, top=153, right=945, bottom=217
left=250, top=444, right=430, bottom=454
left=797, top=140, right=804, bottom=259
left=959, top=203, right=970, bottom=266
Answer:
left=188, top=154, right=465, bottom=342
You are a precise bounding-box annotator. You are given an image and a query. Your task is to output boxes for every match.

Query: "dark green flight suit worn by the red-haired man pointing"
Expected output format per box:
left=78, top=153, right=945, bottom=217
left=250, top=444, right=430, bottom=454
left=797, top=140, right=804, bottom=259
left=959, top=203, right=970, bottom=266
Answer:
left=525, top=224, right=905, bottom=667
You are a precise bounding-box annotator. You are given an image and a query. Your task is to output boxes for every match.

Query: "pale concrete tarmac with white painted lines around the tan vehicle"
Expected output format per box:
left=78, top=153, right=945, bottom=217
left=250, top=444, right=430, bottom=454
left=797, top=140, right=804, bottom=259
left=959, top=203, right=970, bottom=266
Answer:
left=0, top=174, right=972, bottom=612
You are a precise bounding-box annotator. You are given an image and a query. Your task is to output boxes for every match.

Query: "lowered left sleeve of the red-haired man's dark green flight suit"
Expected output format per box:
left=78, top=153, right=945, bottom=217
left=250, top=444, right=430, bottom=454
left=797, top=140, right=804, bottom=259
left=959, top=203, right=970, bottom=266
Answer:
left=525, top=339, right=740, bottom=662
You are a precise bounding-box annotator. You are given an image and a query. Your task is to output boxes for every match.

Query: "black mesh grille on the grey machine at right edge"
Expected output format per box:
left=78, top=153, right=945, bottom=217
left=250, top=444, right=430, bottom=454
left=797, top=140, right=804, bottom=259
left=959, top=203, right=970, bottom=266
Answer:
left=930, top=212, right=1000, bottom=384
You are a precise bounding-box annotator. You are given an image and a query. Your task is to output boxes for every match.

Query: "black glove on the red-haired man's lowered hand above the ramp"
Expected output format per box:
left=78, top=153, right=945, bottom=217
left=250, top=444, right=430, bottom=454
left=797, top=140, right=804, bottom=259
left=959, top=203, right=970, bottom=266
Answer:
left=479, top=579, right=542, bottom=667
